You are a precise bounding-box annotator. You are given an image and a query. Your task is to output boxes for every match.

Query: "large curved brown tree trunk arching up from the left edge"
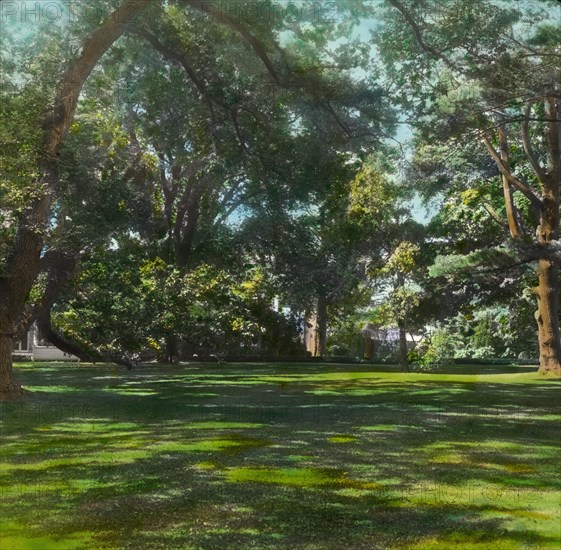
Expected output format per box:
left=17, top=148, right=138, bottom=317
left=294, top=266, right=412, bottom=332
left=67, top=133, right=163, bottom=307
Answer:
left=0, top=0, right=151, bottom=402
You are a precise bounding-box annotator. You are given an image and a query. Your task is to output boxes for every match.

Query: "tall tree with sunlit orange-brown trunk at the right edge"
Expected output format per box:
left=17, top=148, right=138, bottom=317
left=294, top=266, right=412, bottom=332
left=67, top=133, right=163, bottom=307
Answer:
left=377, top=0, right=561, bottom=373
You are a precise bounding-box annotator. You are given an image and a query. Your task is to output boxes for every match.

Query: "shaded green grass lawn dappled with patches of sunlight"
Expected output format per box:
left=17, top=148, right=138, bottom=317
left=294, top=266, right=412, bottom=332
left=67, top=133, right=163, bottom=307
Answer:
left=0, top=364, right=561, bottom=550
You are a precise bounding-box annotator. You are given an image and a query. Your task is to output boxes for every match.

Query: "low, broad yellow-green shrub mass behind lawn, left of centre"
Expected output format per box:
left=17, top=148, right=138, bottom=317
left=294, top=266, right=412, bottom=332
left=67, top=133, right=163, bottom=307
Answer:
left=55, top=241, right=301, bottom=355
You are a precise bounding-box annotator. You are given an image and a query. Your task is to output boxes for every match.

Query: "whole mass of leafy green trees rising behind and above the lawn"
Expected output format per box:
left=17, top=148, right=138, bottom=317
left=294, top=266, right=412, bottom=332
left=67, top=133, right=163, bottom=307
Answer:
left=0, top=0, right=561, bottom=393
